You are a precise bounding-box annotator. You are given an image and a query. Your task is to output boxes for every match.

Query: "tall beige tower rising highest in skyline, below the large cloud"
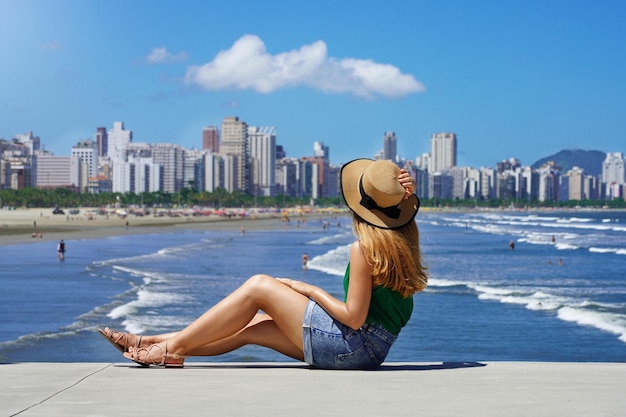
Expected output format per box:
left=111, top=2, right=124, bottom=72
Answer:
left=220, top=116, right=250, bottom=193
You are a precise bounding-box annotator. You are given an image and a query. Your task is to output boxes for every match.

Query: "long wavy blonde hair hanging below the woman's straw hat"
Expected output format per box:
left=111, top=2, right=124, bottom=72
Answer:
left=352, top=213, right=428, bottom=298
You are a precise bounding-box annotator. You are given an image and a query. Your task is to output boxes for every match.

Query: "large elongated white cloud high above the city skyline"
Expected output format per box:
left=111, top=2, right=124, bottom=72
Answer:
left=184, top=35, right=425, bottom=98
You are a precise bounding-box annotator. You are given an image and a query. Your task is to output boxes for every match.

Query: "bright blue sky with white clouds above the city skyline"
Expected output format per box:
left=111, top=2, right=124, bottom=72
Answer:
left=0, top=0, right=626, bottom=167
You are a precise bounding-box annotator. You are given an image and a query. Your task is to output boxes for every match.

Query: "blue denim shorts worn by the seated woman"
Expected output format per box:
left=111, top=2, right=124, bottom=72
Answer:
left=302, top=300, right=397, bottom=369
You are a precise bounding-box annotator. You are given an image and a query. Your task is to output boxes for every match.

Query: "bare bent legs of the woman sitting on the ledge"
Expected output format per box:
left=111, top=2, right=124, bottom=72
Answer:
left=130, top=275, right=308, bottom=360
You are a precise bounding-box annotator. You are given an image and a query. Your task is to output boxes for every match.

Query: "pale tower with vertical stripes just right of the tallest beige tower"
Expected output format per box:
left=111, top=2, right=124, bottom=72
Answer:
left=248, top=126, right=276, bottom=197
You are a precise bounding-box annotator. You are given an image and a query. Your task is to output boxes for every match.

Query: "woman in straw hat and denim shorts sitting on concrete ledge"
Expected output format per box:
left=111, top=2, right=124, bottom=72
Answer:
left=99, top=159, right=427, bottom=369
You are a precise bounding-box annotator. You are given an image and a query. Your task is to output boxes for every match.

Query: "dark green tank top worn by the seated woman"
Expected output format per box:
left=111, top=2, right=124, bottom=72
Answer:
left=343, top=264, right=413, bottom=335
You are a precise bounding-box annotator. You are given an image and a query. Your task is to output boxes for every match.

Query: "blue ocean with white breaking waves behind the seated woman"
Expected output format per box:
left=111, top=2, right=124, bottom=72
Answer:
left=0, top=211, right=626, bottom=363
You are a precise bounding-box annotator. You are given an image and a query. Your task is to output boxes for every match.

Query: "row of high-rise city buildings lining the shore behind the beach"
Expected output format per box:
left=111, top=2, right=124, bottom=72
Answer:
left=0, top=117, right=626, bottom=201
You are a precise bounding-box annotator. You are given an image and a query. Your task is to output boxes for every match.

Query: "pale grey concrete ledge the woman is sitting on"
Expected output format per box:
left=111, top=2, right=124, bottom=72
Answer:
left=0, top=362, right=626, bottom=417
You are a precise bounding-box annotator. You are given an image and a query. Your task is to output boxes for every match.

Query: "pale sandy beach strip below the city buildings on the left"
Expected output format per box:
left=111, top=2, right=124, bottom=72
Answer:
left=0, top=208, right=328, bottom=245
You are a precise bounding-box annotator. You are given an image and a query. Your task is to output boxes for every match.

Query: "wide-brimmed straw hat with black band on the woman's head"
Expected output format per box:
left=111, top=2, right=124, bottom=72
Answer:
left=341, top=159, right=420, bottom=229
